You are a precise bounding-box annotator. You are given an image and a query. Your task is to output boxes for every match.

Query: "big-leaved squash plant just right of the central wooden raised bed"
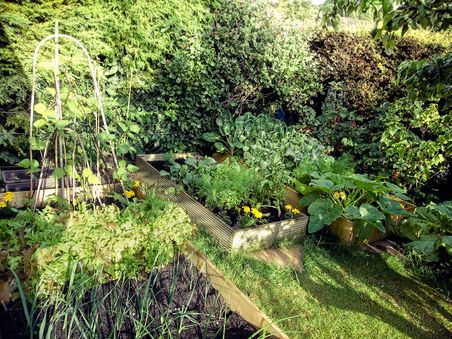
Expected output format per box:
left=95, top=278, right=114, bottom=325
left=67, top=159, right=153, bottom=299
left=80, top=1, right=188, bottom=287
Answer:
left=295, top=159, right=411, bottom=239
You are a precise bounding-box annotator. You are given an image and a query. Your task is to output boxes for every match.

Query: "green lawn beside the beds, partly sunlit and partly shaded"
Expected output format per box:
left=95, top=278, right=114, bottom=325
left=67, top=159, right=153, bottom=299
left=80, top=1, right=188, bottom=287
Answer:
left=195, top=234, right=452, bottom=338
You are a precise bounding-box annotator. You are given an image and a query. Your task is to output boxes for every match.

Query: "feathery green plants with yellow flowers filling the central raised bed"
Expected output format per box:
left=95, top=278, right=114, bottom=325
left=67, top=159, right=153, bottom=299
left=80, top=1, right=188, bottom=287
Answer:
left=160, top=158, right=293, bottom=227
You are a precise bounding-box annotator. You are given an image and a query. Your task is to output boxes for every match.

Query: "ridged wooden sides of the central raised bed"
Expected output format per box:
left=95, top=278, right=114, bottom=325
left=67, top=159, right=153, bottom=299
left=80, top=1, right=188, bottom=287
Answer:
left=134, top=153, right=308, bottom=249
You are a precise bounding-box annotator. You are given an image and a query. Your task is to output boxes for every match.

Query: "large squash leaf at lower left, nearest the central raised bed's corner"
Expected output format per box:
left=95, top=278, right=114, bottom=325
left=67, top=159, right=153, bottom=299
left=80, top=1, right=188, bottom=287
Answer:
left=308, top=198, right=342, bottom=233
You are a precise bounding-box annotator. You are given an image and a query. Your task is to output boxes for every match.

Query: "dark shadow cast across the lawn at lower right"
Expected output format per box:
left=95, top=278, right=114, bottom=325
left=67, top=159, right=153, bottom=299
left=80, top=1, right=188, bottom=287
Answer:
left=298, top=246, right=452, bottom=338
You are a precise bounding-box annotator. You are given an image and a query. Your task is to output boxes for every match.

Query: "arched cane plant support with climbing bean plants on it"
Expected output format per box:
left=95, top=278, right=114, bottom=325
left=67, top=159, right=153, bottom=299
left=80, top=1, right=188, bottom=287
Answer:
left=28, top=24, right=122, bottom=208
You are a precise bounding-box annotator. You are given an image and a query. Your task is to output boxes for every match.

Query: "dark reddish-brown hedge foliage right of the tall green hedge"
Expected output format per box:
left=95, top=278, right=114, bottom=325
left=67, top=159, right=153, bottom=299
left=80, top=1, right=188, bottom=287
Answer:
left=311, top=32, right=443, bottom=121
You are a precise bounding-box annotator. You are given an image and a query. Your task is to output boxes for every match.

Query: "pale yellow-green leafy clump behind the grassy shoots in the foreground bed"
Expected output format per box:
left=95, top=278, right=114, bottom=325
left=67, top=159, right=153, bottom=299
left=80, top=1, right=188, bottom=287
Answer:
left=0, top=194, right=192, bottom=292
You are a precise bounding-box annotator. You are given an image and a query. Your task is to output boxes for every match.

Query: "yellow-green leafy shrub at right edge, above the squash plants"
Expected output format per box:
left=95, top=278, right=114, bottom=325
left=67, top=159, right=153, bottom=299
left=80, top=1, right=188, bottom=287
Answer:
left=381, top=99, right=452, bottom=194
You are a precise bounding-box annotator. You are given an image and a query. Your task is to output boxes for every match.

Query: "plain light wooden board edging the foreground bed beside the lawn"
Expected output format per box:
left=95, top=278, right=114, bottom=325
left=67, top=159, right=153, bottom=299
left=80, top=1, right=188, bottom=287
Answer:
left=185, top=242, right=289, bottom=339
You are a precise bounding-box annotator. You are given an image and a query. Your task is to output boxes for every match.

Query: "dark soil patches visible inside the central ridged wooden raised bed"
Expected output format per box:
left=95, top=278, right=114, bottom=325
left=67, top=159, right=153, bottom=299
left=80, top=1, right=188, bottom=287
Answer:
left=151, top=159, right=294, bottom=229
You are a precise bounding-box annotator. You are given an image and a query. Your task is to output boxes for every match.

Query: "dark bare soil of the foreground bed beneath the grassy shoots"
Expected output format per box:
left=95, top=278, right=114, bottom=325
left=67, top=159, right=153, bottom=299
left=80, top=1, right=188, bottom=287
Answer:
left=0, top=256, right=256, bottom=339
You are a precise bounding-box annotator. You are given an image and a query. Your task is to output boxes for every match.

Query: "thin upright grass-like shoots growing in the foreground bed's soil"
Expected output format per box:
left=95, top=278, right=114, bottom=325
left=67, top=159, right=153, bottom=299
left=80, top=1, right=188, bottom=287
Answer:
left=16, top=253, right=254, bottom=338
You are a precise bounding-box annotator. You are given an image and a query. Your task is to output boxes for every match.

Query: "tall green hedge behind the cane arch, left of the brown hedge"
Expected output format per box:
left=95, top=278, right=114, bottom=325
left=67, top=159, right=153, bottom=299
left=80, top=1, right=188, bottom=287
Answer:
left=0, top=0, right=319, bottom=160
